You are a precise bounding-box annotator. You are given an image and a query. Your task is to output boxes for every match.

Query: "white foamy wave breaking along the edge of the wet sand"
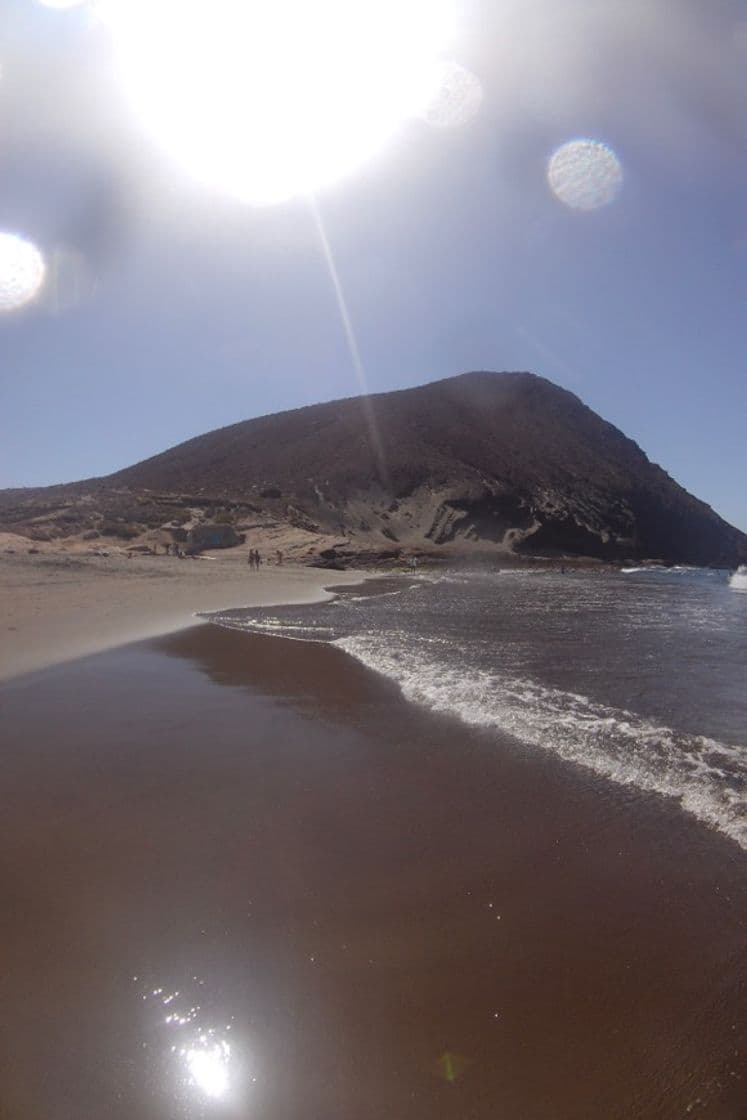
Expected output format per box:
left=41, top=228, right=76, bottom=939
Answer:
left=334, top=634, right=747, bottom=850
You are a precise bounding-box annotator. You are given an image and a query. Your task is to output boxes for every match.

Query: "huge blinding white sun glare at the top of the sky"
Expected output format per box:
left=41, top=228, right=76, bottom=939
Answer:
left=97, top=0, right=455, bottom=205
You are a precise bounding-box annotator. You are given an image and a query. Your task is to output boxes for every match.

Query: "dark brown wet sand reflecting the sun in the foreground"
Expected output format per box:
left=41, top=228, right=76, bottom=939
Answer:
left=0, top=627, right=747, bottom=1120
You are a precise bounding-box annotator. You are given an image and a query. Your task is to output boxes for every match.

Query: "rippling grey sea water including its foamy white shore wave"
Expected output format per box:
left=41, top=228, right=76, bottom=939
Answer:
left=212, top=568, right=747, bottom=849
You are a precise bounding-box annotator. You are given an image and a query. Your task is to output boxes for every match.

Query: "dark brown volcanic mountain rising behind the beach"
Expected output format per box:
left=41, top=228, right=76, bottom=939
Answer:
left=0, top=373, right=747, bottom=567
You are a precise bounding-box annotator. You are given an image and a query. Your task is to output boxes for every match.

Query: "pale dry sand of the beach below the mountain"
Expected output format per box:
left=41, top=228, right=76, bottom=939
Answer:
left=0, top=534, right=361, bottom=680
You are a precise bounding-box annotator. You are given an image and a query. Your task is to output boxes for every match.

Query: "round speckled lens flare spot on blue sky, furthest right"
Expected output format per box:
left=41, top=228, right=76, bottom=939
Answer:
left=548, top=140, right=623, bottom=211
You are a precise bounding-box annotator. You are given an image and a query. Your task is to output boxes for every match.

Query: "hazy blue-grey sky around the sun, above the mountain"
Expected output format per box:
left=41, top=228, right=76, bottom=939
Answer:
left=0, top=0, right=747, bottom=530
